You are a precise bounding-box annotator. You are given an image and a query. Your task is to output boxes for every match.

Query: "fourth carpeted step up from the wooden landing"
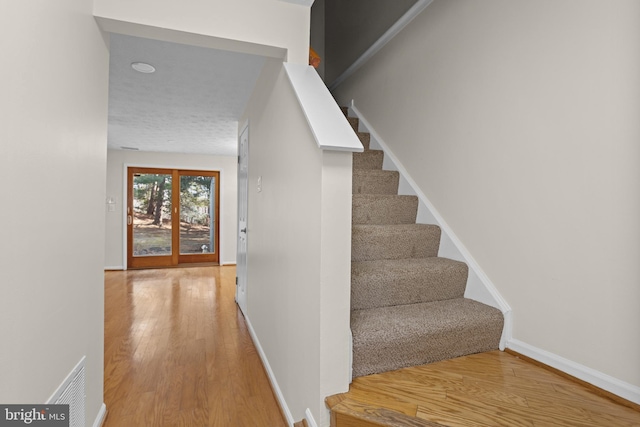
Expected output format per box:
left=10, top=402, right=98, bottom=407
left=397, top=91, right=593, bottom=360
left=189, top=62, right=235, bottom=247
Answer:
left=351, top=194, right=418, bottom=224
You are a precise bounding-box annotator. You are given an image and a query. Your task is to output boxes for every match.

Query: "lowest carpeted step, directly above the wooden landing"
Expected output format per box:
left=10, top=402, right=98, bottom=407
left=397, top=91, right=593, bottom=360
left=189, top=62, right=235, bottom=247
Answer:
left=351, top=298, right=503, bottom=377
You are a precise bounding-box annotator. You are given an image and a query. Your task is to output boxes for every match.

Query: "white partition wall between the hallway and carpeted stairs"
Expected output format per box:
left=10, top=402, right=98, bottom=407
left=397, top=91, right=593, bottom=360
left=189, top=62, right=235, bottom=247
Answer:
left=241, top=60, right=351, bottom=426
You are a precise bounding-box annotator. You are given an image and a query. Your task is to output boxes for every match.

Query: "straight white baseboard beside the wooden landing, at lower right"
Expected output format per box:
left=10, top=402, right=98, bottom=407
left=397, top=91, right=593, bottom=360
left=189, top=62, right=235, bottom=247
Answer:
left=507, top=339, right=640, bottom=405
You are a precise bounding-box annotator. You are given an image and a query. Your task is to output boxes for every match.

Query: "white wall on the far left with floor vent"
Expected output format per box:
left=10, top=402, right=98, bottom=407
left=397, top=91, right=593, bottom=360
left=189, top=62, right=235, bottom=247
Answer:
left=0, top=0, right=109, bottom=425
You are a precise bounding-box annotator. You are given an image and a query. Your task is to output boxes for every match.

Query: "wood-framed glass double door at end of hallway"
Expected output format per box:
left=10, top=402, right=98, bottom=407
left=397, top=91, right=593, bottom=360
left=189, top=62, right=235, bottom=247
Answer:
left=127, top=167, right=220, bottom=268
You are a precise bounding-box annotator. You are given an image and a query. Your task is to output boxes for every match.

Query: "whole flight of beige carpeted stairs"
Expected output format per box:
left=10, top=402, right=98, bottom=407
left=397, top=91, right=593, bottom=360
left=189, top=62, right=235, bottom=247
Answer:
left=343, top=109, right=503, bottom=377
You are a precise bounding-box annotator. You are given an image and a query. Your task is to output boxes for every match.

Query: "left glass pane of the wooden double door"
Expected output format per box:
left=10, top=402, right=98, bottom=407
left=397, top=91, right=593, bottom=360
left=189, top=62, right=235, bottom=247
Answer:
left=133, top=174, right=171, bottom=257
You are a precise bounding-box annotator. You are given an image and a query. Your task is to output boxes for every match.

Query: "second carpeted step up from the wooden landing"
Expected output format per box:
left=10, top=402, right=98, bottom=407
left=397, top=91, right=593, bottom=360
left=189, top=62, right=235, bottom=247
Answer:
left=351, top=257, right=469, bottom=310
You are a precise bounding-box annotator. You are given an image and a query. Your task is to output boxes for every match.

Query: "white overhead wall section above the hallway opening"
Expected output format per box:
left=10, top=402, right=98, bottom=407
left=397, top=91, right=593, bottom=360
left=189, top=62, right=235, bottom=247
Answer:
left=94, top=0, right=310, bottom=64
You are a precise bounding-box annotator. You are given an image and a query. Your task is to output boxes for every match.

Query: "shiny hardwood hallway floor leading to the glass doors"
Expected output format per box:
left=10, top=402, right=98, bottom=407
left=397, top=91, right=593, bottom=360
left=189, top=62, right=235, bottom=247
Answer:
left=104, top=267, right=287, bottom=427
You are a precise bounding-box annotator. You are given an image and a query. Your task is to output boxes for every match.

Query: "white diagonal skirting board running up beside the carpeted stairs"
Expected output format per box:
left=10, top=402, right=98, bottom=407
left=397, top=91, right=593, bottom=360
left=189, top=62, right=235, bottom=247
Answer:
left=349, top=100, right=513, bottom=350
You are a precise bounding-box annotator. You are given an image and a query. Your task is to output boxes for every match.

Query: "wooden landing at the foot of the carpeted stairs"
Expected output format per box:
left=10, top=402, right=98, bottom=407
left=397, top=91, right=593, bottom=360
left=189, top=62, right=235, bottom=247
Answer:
left=326, top=351, right=640, bottom=427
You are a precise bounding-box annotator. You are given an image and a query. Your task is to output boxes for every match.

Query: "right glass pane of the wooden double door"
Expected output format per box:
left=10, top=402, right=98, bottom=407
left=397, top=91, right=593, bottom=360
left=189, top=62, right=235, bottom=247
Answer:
left=180, top=175, right=216, bottom=255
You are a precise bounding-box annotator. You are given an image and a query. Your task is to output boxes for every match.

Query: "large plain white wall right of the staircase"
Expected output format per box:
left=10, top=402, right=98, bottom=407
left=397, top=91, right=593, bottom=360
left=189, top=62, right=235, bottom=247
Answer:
left=336, top=0, right=640, bottom=387
